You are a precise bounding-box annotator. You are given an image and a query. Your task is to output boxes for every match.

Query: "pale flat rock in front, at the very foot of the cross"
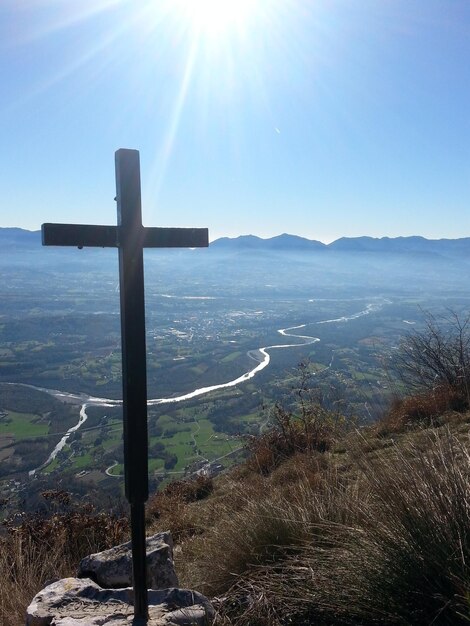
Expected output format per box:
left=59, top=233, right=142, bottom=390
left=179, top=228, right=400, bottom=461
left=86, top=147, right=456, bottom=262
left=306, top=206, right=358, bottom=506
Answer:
left=26, top=578, right=214, bottom=626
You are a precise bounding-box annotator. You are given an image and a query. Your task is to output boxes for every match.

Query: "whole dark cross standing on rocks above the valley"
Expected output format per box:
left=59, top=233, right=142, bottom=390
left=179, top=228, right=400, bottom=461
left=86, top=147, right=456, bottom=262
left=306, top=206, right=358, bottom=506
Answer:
left=42, top=149, right=209, bottom=624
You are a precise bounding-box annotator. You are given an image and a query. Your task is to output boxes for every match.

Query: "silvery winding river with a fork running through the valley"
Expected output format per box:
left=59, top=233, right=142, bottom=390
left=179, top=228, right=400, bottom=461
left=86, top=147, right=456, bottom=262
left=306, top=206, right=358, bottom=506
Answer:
left=25, top=299, right=390, bottom=476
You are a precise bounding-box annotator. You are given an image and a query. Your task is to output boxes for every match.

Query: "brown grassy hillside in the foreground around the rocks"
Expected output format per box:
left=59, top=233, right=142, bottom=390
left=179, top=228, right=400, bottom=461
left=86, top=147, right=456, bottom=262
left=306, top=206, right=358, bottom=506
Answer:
left=0, top=398, right=470, bottom=626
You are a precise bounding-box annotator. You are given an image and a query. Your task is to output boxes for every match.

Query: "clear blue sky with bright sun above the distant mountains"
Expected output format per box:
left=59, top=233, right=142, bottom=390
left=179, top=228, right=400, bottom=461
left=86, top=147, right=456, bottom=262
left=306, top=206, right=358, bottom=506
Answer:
left=0, top=0, right=470, bottom=242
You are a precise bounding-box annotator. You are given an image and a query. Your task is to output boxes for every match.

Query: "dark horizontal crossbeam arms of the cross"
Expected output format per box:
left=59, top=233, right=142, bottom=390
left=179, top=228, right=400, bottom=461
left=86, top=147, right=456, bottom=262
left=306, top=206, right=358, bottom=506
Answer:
left=41, top=224, right=209, bottom=248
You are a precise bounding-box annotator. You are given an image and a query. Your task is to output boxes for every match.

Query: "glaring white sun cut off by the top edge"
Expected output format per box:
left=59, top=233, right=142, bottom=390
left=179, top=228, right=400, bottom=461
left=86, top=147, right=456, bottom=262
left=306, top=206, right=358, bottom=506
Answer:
left=174, top=0, right=260, bottom=36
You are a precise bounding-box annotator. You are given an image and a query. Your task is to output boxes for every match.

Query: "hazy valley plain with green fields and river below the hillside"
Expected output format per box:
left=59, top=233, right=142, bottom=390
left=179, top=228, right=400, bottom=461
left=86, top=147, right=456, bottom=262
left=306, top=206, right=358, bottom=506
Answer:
left=0, top=235, right=468, bottom=509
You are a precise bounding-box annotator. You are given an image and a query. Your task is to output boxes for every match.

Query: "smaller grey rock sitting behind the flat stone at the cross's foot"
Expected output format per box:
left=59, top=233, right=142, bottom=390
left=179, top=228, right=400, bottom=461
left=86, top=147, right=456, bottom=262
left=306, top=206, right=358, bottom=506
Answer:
left=78, top=532, right=178, bottom=589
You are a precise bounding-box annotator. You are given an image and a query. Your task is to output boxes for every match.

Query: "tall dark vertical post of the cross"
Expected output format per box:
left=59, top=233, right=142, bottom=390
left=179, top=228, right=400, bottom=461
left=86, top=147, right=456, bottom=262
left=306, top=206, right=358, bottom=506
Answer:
left=115, top=150, right=148, bottom=619
